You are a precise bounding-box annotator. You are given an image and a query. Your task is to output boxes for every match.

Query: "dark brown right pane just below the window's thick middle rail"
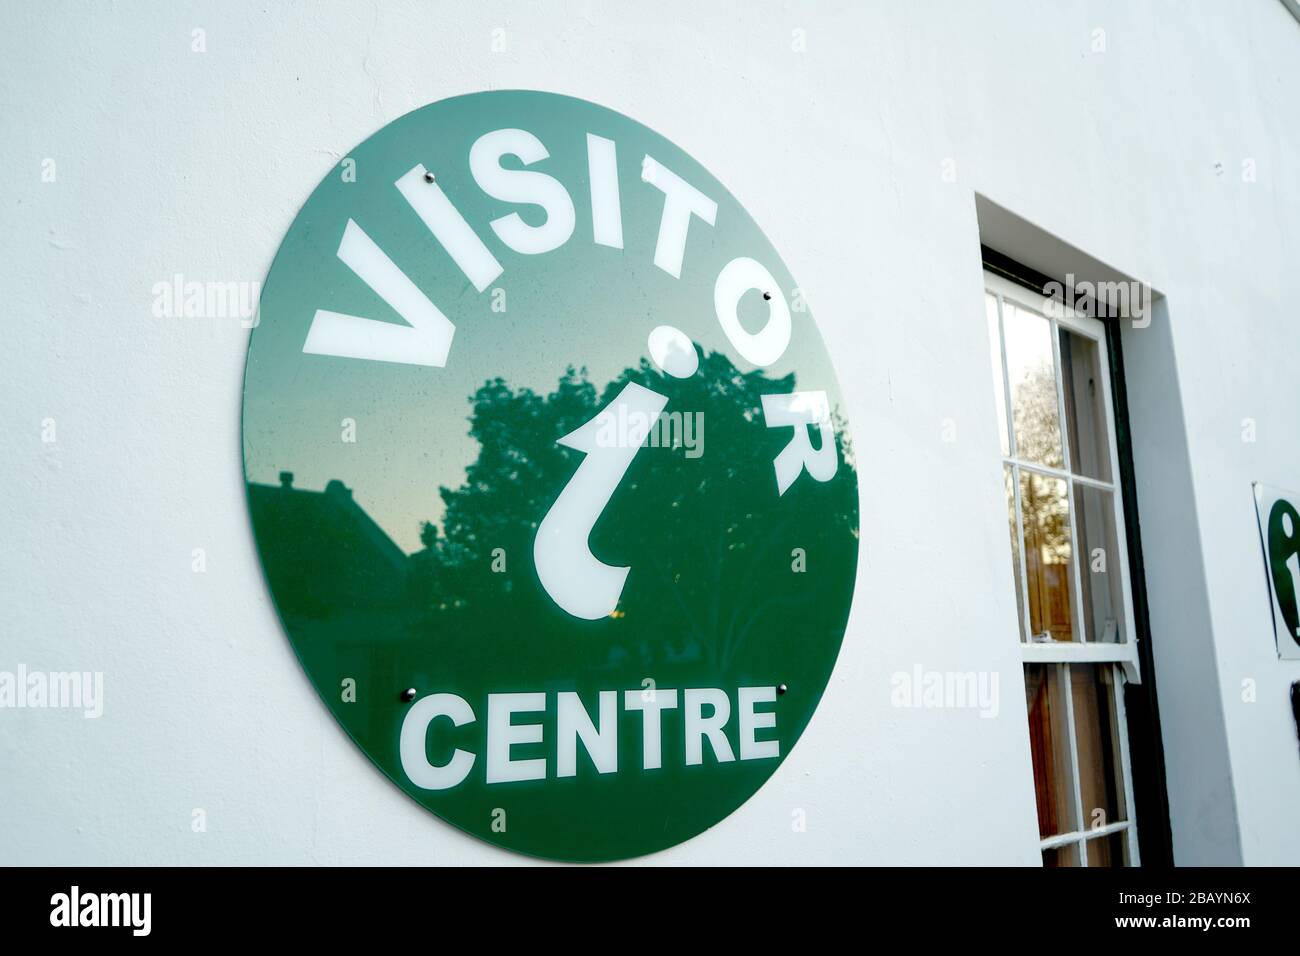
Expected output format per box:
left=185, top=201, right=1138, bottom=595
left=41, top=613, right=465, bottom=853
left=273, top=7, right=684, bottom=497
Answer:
left=1070, top=665, right=1125, bottom=830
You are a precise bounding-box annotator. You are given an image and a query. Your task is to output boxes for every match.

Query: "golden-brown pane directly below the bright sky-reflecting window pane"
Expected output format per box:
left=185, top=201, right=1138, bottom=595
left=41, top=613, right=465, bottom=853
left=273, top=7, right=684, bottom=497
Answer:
left=1021, top=468, right=1075, bottom=641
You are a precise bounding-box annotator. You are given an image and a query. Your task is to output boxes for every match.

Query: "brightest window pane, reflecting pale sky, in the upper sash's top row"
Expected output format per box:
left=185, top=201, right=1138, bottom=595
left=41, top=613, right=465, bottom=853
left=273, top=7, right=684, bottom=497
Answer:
left=1002, top=300, right=1063, bottom=468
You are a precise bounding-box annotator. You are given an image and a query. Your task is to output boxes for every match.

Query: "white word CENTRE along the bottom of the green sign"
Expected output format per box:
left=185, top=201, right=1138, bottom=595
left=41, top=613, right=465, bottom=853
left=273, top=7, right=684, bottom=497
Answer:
left=399, top=685, right=780, bottom=790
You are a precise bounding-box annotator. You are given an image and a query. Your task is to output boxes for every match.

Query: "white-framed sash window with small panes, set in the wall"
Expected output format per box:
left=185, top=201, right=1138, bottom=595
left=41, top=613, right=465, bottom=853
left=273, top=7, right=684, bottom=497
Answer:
left=984, top=272, right=1138, bottom=866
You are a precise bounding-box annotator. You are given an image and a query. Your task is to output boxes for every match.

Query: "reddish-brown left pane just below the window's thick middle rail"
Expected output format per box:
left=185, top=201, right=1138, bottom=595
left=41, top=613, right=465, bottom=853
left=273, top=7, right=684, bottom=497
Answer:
left=1024, top=663, right=1078, bottom=836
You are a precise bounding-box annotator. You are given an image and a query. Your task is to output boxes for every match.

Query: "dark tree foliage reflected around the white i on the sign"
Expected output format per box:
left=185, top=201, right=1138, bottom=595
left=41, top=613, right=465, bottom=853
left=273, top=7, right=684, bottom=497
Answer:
left=412, top=352, right=857, bottom=666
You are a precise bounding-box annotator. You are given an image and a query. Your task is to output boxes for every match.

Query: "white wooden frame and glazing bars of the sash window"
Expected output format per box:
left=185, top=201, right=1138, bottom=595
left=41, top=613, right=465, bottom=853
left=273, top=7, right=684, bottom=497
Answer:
left=980, top=269, right=1141, bottom=866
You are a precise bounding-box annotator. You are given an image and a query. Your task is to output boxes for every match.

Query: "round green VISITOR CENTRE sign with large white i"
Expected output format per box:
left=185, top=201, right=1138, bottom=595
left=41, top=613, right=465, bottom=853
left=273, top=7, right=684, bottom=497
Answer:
left=243, top=91, right=858, bottom=860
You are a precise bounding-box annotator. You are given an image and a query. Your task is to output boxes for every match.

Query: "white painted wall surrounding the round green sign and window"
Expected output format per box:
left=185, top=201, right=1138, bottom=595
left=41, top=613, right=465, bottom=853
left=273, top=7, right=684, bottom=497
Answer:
left=0, top=0, right=1300, bottom=864
